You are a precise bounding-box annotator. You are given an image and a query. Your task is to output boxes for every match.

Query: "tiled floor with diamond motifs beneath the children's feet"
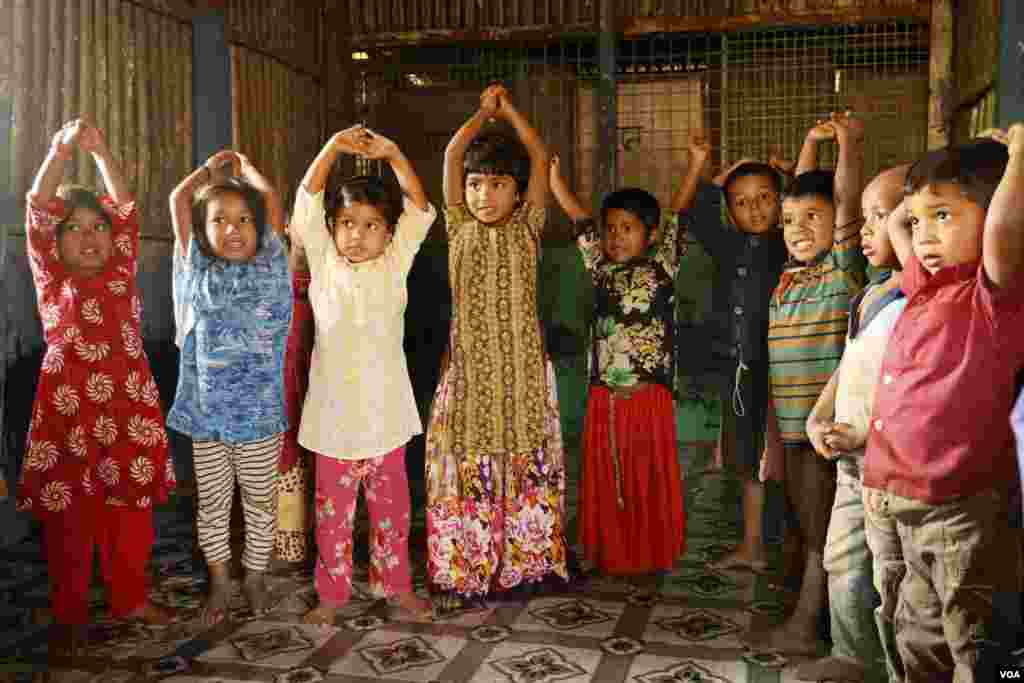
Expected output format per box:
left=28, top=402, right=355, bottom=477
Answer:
left=0, top=448, right=823, bottom=683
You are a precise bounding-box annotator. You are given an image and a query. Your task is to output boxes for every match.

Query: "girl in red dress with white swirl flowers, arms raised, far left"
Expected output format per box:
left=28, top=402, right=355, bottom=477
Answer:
left=17, top=120, right=174, bottom=645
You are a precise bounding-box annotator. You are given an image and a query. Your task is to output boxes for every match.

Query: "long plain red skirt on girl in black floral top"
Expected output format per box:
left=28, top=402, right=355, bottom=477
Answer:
left=579, top=385, right=686, bottom=574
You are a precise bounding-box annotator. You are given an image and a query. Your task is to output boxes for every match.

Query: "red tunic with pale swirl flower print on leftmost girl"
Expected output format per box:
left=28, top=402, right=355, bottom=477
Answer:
left=17, top=197, right=175, bottom=520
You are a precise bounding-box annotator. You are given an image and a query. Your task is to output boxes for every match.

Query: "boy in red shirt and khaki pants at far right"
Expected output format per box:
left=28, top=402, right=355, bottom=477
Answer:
left=863, top=124, right=1024, bottom=683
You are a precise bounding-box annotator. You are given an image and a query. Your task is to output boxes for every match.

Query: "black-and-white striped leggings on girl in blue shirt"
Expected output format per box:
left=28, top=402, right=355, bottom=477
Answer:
left=193, top=434, right=284, bottom=571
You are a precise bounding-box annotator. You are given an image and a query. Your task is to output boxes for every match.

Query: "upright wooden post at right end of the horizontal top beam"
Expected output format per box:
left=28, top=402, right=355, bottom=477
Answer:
left=928, top=0, right=956, bottom=150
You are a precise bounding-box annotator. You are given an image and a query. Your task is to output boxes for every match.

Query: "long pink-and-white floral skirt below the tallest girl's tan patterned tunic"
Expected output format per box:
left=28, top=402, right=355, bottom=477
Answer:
left=426, top=362, right=568, bottom=596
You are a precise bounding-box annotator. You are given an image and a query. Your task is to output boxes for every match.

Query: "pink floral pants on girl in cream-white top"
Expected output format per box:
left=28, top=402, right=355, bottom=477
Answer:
left=314, top=446, right=413, bottom=607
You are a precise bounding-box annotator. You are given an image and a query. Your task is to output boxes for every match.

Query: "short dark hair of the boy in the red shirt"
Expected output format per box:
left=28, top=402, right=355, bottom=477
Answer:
left=903, top=138, right=1010, bottom=211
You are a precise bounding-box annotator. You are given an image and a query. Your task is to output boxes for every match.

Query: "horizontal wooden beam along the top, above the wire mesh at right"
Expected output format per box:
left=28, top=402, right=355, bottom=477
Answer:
left=622, top=2, right=932, bottom=37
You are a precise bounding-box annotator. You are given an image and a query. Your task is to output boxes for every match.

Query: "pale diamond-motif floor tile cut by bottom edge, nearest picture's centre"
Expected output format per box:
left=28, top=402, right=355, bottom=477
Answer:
left=470, top=642, right=601, bottom=683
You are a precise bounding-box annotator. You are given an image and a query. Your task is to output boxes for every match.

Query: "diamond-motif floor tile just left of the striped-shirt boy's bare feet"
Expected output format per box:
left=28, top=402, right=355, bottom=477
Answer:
left=643, top=605, right=751, bottom=649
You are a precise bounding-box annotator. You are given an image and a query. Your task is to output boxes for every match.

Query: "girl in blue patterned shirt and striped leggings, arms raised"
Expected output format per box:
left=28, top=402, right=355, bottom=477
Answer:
left=167, top=151, right=292, bottom=625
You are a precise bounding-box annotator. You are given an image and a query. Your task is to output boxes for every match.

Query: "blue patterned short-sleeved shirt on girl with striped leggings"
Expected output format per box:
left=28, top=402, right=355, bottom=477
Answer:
left=167, top=230, right=292, bottom=443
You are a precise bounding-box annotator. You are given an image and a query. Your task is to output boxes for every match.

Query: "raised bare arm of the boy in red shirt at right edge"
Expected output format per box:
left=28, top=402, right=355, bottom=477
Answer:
left=981, top=123, right=1024, bottom=287
